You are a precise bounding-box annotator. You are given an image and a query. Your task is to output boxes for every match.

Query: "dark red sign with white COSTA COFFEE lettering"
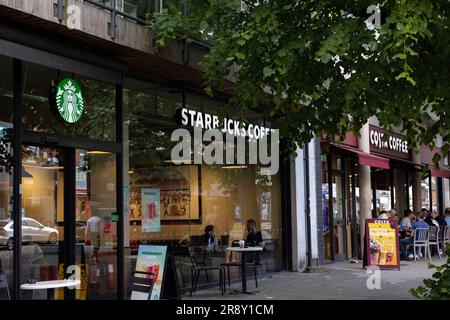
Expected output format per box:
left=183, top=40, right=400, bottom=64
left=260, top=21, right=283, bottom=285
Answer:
left=369, top=125, right=410, bottom=160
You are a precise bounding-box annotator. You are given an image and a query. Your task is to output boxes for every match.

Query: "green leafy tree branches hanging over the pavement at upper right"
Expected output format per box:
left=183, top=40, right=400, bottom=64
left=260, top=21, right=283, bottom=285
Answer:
left=149, top=0, right=450, bottom=162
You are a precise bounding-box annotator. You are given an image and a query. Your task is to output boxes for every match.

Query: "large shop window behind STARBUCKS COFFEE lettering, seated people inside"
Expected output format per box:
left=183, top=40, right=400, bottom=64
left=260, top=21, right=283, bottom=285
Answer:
left=124, top=84, right=282, bottom=288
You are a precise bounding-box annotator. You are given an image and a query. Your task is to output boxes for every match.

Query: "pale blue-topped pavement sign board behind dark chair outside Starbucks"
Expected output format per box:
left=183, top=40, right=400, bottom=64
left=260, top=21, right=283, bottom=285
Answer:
left=131, top=245, right=167, bottom=300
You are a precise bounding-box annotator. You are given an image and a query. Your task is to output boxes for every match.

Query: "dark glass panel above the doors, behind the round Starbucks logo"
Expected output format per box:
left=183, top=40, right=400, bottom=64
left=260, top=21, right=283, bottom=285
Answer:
left=22, top=62, right=116, bottom=141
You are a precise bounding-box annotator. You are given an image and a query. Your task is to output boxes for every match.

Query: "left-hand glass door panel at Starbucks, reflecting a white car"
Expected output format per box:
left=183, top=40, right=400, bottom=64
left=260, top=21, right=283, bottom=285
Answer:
left=21, top=145, right=66, bottom=299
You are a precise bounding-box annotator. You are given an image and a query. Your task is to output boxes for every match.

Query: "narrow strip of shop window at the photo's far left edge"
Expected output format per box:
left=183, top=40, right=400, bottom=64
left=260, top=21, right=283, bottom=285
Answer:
left=0, top=56, right=14, bottom=300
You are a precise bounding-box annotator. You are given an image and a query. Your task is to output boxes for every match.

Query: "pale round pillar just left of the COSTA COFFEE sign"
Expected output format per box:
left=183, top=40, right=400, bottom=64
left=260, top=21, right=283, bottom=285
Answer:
left=358, top=123, right=372, bottom=256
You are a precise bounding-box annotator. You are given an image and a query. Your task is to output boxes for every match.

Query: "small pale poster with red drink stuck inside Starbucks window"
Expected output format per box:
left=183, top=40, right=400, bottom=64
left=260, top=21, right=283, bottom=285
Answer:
left=141, top=188, right=161, bottom=232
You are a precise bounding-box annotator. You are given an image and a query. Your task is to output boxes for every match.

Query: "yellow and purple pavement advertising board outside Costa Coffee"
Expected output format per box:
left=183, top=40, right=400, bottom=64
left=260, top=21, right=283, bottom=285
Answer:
left=366, top=219, right=400, bottom=269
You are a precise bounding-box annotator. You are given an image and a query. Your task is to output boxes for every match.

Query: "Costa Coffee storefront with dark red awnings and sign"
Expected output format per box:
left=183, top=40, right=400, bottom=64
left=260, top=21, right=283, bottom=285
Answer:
left=322, top=125, right=421, bottom=261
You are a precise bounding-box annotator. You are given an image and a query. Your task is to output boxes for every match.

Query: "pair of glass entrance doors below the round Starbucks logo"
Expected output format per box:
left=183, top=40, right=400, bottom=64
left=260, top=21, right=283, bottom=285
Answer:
left=21, top=145, right=118, bottom=300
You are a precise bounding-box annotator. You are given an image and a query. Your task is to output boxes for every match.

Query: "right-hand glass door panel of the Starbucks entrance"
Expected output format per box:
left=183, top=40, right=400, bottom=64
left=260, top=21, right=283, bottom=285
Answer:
left=75, top=149, right=118, bottom=300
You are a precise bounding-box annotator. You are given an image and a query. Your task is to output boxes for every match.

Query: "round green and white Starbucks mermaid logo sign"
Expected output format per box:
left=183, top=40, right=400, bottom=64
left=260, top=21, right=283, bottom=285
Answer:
left=56, top=78, right=84, bottom=123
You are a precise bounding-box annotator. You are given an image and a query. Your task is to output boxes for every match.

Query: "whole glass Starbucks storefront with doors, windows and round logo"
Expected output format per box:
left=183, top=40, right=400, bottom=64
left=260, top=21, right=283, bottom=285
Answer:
left=0, top=40, right=287, bottom=300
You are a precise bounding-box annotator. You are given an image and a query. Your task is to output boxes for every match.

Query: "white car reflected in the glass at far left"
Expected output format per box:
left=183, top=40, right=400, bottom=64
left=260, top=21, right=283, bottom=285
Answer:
left=0, top=218, right=59, bottom=250
